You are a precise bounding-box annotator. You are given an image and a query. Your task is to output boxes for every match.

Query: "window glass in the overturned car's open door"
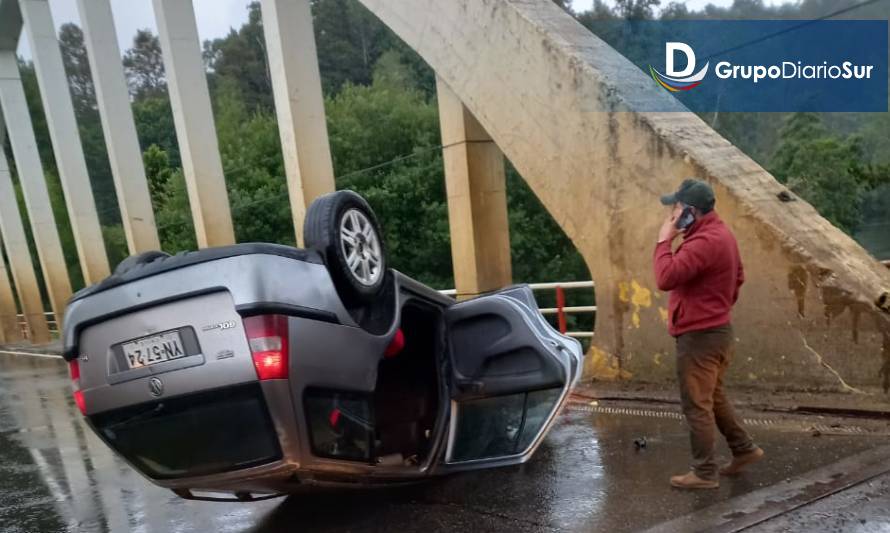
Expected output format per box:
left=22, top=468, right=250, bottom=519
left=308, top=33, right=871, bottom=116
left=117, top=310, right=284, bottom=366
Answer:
left=449, top=388, right=562, bottom=462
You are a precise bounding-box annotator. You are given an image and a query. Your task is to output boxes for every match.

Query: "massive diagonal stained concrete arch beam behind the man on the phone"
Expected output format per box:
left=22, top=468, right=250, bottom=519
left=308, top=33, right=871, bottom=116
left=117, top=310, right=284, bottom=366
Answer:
left=361, top=0, right=890, bottom=391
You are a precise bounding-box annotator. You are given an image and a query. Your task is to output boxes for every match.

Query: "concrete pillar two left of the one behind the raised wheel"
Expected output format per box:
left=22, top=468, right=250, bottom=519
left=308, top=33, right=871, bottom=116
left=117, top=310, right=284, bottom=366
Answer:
left=77, top=0, right=161, bottom=254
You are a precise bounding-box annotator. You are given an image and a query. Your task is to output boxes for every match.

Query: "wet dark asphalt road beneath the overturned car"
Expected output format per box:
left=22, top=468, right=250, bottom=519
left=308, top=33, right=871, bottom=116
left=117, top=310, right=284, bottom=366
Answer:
left=0, top=354, right=886, bottom=533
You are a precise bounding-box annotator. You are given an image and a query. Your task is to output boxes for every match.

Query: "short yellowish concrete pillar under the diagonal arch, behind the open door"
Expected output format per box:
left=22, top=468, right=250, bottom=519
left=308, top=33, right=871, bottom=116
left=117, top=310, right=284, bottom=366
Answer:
left=436, top=79, right=512, bottom=297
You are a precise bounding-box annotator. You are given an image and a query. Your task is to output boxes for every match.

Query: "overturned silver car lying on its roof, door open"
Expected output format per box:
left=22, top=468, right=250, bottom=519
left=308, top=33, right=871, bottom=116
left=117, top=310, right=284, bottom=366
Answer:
left=63, top=191, right=583, bottom=501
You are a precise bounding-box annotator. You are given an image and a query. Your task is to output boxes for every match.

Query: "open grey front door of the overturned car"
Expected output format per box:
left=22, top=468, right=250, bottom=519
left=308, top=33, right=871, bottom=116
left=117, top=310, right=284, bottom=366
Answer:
left=440, top=286, right=582, bottom=471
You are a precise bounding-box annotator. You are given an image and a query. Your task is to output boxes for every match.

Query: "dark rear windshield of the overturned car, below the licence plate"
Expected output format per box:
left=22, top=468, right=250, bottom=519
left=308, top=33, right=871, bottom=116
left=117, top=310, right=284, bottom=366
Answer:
left=90, top=384, right=281, bottom=479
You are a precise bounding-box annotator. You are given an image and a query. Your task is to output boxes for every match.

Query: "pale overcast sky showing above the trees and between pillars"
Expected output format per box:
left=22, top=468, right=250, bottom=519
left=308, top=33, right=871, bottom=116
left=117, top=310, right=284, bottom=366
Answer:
left=19, top=0, right=782, bottom=58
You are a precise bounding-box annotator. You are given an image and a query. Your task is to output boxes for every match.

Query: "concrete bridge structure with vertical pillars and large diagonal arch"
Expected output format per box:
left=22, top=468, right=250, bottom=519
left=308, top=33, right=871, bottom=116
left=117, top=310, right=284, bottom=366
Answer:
left=0, top=0, right=890, bottom=398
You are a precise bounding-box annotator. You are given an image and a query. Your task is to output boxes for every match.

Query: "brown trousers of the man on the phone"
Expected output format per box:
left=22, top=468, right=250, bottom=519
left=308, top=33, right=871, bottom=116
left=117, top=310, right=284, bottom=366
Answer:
left=677, top=326, right=756, bottom=479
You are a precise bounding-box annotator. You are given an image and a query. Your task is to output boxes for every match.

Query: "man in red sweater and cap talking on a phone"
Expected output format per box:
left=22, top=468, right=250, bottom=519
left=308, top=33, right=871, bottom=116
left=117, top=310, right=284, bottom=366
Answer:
left=655, top=179, right=763, bottom=489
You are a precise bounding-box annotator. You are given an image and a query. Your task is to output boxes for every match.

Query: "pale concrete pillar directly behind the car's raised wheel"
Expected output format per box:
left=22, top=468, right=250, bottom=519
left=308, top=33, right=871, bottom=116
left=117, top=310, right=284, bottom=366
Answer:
left=261, top=0, right=334, bottom=246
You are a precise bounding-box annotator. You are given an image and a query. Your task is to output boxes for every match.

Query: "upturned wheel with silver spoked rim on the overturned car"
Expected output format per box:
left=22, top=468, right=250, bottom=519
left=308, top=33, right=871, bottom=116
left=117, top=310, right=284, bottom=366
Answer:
left=303, top=191, right=387, bottom=305
